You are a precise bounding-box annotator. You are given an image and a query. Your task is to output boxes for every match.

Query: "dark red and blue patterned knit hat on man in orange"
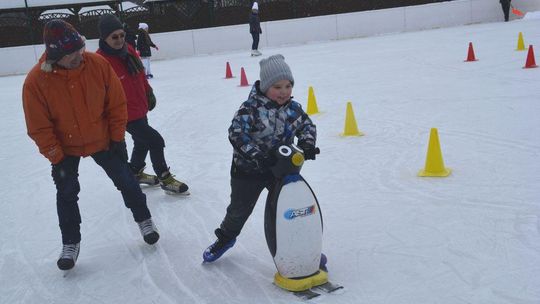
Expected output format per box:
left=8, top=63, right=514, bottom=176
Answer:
left=43, top=19, right=85, bottom=64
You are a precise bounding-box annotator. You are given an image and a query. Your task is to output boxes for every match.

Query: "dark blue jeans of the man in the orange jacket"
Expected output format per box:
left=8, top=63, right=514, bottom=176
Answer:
left=52, top=151, right=151, bottom=244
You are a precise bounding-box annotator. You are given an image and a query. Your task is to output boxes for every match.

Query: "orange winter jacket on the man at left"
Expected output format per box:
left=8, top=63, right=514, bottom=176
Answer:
left=23, top=52, right=127, bottom=164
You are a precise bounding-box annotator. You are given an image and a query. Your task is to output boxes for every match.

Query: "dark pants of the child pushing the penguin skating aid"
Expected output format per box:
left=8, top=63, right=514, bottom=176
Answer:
left=216, top=177, right=274, bottom=239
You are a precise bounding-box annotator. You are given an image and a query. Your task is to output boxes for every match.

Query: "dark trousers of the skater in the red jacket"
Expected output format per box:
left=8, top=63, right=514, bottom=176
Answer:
left=127, top=116, right=169, bottom=176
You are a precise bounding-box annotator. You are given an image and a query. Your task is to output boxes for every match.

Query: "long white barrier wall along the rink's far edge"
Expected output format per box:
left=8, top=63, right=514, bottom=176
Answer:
left=0, top=0, right=540, bottom=76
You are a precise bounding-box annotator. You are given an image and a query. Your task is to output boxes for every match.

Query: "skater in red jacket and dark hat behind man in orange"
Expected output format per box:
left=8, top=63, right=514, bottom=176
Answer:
left=97, top=14, right=189, bottom=194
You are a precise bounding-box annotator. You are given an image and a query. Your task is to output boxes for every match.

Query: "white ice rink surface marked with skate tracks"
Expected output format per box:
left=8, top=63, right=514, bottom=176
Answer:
left=0, top=19, right=540, bottom=304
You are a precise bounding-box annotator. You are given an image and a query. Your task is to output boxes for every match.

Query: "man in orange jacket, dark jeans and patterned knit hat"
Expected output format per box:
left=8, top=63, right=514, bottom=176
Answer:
left=23, top=20, right=159, bottom=270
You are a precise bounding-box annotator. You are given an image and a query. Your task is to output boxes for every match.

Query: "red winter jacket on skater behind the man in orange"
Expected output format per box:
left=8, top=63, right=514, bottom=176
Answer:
left=96, top=44, right=151, bottom=122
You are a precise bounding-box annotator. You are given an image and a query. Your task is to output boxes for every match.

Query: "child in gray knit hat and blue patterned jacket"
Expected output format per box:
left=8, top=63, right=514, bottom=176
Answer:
left=203, top=55, right=319, bottom=262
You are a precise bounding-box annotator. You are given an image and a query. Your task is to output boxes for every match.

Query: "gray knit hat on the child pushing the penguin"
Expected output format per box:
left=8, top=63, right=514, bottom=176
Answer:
left=259, top=54, right=294, bottom=93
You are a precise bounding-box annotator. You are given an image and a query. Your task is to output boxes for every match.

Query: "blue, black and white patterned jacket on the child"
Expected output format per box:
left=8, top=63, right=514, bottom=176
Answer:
left=229, top=81, right=317, bottom=177
